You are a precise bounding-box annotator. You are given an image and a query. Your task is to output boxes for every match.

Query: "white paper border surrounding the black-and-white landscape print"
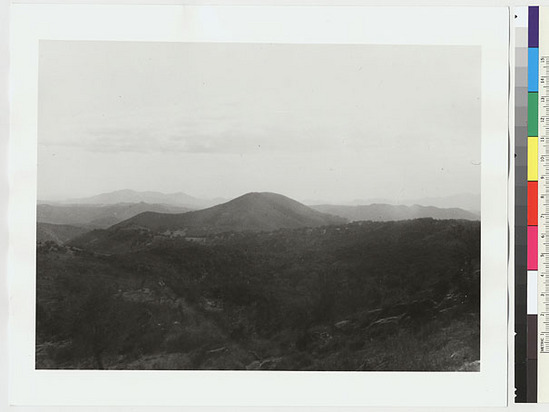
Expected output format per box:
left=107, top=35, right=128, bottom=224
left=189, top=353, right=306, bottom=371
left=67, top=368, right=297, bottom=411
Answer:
left=8, top=4, right=509, bottom=407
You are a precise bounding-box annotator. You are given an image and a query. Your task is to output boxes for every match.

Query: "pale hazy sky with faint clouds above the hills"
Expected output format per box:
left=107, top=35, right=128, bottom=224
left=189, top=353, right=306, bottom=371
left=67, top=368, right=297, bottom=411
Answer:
left=38, top=41, right=481, bottom=202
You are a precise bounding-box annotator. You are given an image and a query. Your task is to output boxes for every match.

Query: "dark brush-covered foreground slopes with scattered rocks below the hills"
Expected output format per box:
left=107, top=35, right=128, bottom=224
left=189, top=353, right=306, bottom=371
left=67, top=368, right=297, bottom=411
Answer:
left=36, top=219, right=480, bottom=370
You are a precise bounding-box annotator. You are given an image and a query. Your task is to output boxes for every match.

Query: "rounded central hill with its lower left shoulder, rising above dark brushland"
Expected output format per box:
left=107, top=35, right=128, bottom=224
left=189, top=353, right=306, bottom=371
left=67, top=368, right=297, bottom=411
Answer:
left=113, top=193, right=347, bottom=234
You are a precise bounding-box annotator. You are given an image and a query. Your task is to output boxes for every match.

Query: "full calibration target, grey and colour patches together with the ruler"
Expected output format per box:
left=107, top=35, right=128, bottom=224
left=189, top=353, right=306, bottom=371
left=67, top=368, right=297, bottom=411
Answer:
left=514, top=6, right=549, bottom=403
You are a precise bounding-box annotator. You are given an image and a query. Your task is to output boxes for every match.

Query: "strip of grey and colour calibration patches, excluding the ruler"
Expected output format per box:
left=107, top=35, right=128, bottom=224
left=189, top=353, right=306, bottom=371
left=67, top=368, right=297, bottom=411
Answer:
left=514, top=6, right=539, bottom=403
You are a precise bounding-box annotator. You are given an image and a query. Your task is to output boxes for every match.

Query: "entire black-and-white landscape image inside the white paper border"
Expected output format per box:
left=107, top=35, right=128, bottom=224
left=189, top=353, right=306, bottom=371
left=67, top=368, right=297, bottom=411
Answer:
left=35, top=40, right=481, bottom=372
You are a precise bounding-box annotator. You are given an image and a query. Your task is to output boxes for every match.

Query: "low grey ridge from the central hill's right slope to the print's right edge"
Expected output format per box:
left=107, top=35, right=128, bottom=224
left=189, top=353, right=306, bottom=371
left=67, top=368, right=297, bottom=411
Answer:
left=311, top=203, right=480, bottom=221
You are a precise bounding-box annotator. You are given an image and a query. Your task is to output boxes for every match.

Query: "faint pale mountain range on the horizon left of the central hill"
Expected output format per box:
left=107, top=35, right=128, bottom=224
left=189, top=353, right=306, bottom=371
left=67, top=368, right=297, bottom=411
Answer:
left=39, top=189, right=226, bottom=209
